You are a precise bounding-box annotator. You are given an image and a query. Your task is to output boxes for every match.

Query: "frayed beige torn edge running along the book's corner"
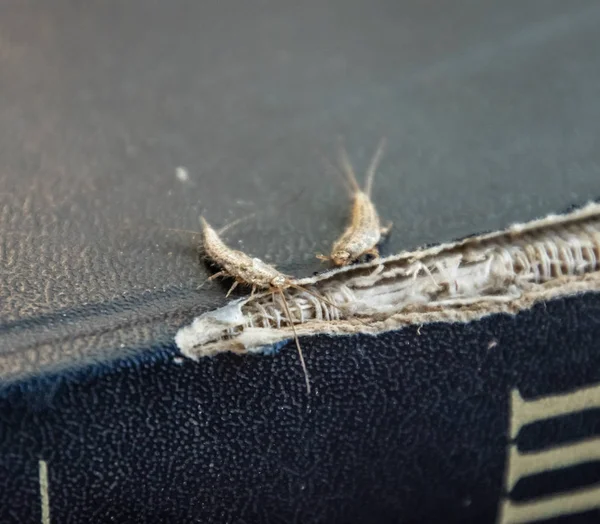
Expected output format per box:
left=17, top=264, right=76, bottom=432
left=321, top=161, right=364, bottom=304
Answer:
left=175, top=203, right=600, bottom=359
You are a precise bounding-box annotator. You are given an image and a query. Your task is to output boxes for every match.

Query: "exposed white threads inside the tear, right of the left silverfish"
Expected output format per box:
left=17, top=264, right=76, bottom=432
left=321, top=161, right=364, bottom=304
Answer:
left=249, top=220, right=600, bottom=327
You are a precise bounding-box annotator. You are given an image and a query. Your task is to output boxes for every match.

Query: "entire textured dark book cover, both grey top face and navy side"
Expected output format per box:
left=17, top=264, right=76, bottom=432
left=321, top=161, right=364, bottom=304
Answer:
left=0, top=0, right=600, bottom=522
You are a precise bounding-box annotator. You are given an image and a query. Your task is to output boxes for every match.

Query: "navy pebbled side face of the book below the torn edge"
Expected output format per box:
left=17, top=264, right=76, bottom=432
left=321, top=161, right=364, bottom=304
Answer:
left=0, top=294, right=600, bottom=523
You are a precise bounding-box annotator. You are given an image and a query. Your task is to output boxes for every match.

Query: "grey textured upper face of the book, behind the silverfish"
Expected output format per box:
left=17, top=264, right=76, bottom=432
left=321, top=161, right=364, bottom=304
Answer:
left=0, top=0, right=600, bottom=376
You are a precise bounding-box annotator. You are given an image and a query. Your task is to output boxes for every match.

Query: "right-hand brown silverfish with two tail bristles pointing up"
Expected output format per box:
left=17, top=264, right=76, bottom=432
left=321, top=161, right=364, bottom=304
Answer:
left=317, top=140, right=392, bottom=266
